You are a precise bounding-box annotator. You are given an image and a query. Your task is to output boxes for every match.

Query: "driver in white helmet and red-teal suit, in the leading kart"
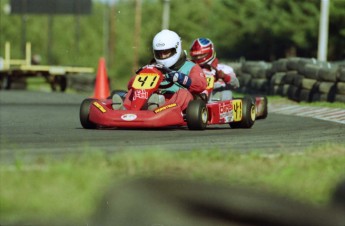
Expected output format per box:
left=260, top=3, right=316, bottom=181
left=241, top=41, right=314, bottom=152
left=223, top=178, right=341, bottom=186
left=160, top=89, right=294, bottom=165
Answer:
left=113, top=30, right=207, bottom=111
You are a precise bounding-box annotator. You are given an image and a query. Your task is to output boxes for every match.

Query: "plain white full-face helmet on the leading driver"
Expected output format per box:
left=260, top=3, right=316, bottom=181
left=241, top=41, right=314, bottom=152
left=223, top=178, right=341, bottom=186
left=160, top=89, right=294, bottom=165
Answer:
left=152, top=30, right=182, bottom=67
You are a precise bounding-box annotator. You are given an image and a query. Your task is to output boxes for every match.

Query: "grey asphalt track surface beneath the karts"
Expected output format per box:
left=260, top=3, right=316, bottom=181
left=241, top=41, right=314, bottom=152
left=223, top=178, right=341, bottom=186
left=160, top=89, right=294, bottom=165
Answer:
left=0, top=90, right=345, bottom=162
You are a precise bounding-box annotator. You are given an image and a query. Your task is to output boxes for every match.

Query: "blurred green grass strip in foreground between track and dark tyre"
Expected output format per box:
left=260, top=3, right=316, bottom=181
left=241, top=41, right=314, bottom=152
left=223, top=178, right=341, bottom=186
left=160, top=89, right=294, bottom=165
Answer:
left=0, top=144, right=345, bottom=223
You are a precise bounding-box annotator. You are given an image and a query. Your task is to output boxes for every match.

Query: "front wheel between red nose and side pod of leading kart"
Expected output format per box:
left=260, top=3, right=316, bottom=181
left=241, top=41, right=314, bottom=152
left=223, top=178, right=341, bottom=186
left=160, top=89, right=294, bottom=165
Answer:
left=186, top=100, right=208, bottom=130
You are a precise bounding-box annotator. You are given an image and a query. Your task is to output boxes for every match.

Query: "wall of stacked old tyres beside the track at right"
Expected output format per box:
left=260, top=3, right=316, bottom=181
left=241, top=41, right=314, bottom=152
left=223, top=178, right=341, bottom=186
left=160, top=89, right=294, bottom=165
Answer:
left=235, top=57, right=345, bottom=103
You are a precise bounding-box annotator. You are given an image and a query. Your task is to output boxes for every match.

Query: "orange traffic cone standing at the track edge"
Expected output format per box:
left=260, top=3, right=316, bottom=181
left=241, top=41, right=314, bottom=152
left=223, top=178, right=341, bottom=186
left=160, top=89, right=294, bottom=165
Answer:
left=93, top=57, right=110, bottom=99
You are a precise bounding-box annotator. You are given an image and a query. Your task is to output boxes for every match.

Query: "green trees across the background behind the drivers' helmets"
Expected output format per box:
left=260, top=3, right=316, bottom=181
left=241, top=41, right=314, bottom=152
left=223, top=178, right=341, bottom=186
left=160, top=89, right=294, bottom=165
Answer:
left=0, top=0, right=345, bottom=87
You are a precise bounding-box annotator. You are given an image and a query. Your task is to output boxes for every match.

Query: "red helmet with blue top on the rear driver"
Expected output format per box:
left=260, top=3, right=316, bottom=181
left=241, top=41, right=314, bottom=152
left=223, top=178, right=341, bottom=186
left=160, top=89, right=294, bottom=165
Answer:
left=189, top=38, right=216, bottom=65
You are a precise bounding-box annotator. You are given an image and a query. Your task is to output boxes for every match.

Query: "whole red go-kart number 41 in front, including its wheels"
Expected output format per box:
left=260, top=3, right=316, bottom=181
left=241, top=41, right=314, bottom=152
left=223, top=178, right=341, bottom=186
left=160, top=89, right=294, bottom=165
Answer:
left=80, top=65, right=267, bottom=130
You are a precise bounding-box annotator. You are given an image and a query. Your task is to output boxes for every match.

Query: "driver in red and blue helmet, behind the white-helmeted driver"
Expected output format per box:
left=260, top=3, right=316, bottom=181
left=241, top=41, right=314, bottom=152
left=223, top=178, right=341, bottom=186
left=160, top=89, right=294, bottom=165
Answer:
left=190, top=38, right=240, bottom=100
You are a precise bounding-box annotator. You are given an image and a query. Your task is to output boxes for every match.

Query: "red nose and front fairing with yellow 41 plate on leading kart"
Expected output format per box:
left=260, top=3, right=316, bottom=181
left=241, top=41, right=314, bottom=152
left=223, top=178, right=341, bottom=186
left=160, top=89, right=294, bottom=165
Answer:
left=89, top=67, right=186, bottom=128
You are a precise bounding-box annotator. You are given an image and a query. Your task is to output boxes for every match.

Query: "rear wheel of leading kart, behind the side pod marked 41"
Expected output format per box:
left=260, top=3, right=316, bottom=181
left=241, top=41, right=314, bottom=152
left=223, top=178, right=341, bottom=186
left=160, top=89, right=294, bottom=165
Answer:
left=229, top=96, right=256, bottom=129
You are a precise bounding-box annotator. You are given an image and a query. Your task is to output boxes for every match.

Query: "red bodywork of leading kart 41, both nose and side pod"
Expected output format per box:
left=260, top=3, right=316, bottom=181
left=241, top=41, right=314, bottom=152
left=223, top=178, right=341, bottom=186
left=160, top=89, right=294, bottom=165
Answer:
left=89, top=66, right=262, bottom=128
